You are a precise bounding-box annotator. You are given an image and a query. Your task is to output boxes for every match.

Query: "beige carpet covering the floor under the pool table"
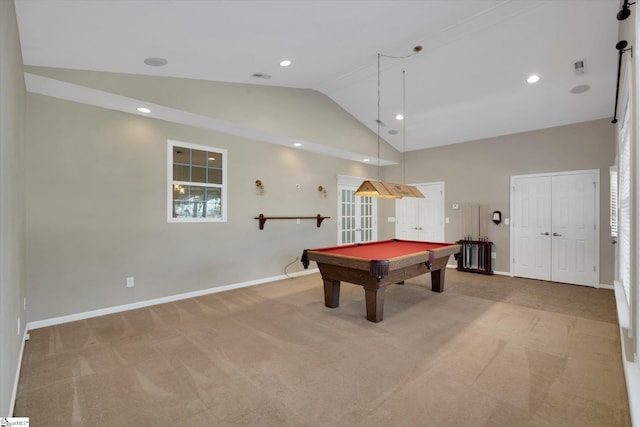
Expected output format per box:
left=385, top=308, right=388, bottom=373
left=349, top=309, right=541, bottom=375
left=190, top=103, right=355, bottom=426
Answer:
left=14, top=270, right=630, bottom=427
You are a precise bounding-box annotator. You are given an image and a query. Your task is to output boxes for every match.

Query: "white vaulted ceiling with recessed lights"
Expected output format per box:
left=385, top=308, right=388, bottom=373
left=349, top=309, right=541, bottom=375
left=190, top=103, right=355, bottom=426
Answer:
left=16, top=0, right=619, bottom=151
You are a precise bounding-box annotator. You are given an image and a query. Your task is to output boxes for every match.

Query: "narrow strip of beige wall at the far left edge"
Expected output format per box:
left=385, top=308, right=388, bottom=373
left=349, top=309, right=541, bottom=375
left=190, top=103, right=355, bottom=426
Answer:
left=0, top=1, right=27, bottom=416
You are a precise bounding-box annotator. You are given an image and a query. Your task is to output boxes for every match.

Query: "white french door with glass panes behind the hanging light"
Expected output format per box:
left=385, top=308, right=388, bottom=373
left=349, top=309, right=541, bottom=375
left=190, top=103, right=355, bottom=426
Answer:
left=338, top=179, right=378, bottom=245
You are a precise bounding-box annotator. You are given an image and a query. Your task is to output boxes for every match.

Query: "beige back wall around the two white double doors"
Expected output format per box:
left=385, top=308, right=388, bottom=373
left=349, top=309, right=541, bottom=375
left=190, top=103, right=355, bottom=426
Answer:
left=380, top=117, right=615, bottom=285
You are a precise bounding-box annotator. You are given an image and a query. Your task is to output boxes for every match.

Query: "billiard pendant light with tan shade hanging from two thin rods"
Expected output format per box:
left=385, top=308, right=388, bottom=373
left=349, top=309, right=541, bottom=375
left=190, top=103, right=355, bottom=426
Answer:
left=355, top=46, right=424, bottom=199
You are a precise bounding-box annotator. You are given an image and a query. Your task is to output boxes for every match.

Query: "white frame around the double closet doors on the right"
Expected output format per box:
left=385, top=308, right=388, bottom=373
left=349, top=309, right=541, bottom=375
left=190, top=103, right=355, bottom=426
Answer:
left=509, top=169, right=601, bottom=288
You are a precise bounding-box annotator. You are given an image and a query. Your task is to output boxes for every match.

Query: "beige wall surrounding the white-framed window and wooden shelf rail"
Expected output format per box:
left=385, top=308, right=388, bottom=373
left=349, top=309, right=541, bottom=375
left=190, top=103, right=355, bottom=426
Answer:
left=26, top=94, right=374, bottom=321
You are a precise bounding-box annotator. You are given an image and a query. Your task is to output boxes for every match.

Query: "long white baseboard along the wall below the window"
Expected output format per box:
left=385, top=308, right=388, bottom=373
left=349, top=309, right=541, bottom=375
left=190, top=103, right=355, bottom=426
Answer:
left=26, top=268, right=319, bottom=331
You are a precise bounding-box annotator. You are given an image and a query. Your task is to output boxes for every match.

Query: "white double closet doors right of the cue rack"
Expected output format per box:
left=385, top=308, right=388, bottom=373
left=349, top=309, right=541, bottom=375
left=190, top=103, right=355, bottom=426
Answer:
left=511, top=170, right=600, bottom=286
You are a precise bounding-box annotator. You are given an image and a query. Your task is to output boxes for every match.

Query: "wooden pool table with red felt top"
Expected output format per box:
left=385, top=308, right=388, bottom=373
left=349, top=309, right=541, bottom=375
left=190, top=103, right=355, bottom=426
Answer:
left=301, top=239, right=460, bottom=322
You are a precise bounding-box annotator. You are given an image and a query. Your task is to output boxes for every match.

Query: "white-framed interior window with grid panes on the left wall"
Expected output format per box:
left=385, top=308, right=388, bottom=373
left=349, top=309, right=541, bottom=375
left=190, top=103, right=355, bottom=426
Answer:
left=167, top=140, right=227, bottom=222
